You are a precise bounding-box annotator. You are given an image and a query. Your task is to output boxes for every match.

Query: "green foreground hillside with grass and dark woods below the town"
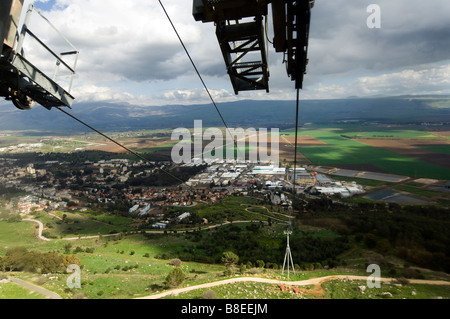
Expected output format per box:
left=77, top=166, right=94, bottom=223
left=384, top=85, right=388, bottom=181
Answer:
left=0, top=197, right=450, bottom=299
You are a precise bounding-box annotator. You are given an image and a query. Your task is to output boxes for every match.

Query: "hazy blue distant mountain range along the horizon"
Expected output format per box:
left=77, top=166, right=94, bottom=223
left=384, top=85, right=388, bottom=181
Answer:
left=0, top=96, right=450, bottom=133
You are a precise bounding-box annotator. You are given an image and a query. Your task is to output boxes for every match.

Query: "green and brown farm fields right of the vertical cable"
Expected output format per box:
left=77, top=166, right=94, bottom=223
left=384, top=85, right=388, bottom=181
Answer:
left=281, top=125, right=450, bottom=180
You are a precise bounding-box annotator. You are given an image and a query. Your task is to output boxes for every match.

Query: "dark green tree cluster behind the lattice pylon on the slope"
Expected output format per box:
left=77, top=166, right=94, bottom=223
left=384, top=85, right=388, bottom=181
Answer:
left=171, top=223, right=351, bottom=268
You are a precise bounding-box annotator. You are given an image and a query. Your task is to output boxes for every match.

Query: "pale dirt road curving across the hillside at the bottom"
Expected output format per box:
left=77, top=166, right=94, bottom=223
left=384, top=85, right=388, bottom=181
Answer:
left=137, top=275, right=450, bottom=299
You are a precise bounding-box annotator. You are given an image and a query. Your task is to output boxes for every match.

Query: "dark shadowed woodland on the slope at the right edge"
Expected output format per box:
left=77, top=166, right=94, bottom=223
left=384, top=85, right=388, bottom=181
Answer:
left=298, top=203, right=450, bottom=272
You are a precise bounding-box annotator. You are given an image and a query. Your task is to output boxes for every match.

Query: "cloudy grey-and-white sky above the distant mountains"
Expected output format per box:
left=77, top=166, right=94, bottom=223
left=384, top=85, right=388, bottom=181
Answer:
left=6, top=0, right=450, bottom=106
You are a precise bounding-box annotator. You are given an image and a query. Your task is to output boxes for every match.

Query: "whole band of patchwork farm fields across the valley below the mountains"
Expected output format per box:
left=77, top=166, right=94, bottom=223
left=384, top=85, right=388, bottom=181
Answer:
left=5, top=124, right=450, bottom=180
